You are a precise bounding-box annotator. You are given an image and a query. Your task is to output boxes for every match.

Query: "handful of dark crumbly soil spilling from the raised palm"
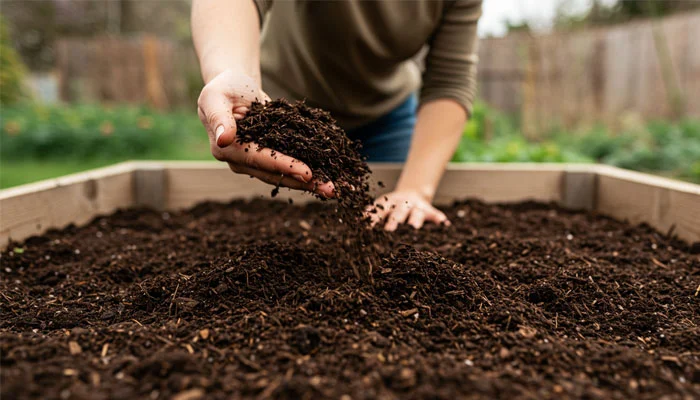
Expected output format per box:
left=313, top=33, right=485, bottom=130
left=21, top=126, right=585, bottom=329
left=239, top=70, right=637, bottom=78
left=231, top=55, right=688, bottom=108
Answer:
left=237, top=99, right=372, bottom=209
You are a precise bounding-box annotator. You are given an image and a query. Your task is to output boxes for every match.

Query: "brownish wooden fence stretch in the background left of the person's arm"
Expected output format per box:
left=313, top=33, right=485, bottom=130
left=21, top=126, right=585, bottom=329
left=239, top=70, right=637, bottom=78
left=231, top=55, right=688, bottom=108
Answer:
left=56, top=36, right=201, bottom=109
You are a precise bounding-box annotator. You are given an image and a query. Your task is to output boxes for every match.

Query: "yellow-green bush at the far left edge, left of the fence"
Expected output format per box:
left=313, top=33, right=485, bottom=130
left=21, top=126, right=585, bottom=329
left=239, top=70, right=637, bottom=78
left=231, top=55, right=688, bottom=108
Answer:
left=0, top=15, right=25, bottom=106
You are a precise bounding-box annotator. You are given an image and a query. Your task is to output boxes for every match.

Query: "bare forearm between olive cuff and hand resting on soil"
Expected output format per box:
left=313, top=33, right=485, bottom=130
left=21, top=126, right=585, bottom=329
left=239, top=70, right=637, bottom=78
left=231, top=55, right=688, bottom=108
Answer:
left=396, top=99, right=467, bottom=201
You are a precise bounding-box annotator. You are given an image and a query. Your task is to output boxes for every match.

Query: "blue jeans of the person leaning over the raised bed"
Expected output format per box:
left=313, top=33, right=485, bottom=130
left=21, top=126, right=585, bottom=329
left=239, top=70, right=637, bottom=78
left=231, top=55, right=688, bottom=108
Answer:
left=347, top=94, right=418, bottom=162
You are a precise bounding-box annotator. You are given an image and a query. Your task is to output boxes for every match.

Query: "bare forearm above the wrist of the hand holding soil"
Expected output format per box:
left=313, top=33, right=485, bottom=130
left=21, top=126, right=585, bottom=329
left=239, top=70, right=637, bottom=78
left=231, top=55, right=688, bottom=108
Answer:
left=192, top=0, right=260, bottom=85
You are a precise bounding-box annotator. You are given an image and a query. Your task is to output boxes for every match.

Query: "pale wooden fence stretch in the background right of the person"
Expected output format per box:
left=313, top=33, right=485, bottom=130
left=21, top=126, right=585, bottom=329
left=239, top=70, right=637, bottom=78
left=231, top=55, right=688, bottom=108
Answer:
left=479, top=12, right=700, bottom=135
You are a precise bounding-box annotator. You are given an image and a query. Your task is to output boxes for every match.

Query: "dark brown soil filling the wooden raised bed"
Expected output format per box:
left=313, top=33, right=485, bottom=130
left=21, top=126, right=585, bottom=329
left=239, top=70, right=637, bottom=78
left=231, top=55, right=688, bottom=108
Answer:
left=0, top=200, right=700, bottom=400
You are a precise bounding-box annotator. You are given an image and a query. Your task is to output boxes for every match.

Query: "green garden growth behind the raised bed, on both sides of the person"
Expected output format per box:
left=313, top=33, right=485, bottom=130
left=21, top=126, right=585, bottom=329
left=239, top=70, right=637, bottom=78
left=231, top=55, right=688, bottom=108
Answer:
left=0, top=102, right=700, bottom=187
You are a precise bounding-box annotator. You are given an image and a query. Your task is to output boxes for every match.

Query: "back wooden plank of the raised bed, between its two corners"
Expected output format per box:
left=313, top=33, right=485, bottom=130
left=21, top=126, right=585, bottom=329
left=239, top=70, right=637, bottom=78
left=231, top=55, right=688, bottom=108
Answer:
left=160, top=162, right=593, bottom=209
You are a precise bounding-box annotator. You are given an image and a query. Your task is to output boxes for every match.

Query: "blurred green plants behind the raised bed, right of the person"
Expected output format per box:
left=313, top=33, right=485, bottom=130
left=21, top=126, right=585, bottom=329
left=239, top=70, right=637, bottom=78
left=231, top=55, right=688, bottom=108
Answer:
left=453, top=102, right=700, bottom=182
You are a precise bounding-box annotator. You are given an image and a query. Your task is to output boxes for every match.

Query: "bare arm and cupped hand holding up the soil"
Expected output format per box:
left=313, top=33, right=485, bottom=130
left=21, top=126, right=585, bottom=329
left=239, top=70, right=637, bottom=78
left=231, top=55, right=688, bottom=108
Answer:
left=192, top=0, right=333, bottom=197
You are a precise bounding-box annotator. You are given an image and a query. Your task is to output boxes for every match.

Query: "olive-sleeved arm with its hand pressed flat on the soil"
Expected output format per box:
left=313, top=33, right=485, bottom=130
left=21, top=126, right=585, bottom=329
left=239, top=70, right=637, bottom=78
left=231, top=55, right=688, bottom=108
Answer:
left=370, top=0, right=481, bottom=231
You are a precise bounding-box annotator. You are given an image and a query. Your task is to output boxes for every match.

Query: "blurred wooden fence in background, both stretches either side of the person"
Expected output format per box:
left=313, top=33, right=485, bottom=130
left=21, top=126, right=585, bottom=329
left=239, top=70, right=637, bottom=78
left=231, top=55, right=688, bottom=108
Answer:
left=57, top=12, right=700, bottom=129
